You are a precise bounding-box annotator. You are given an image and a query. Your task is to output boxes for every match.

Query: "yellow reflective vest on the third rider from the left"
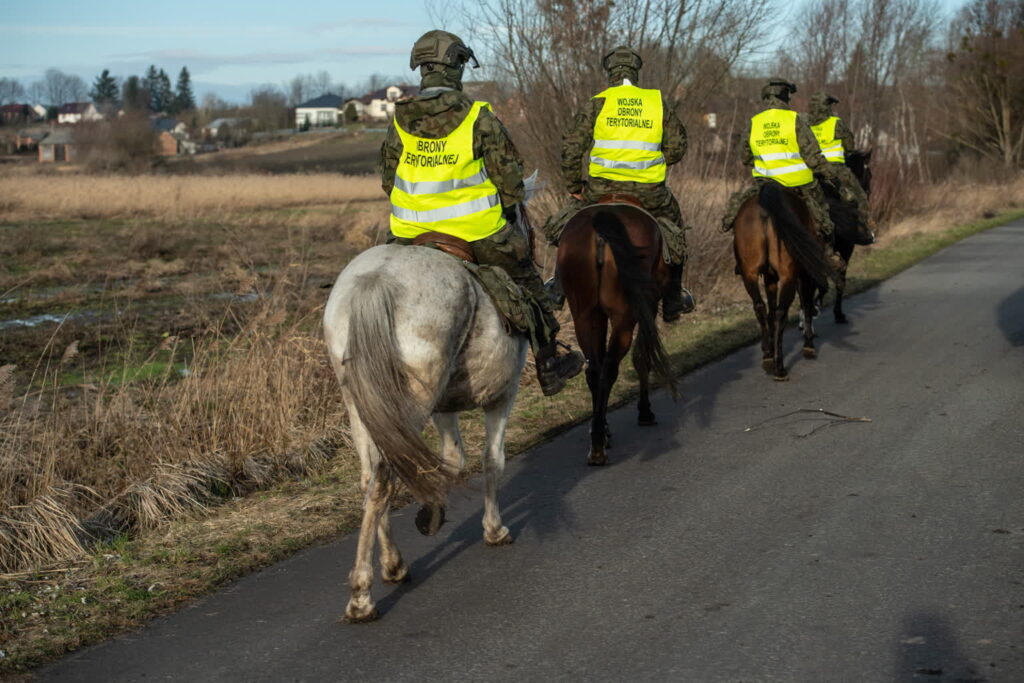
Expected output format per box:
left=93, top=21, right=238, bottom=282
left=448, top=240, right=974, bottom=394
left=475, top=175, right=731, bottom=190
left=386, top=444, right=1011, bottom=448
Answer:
left=750, top=109, right=814, bottom=187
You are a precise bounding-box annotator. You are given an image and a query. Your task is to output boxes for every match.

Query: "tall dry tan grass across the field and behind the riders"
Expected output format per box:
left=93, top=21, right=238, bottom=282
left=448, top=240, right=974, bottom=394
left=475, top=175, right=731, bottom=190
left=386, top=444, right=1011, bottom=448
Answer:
left=0, top=166, right=1024, bottom=571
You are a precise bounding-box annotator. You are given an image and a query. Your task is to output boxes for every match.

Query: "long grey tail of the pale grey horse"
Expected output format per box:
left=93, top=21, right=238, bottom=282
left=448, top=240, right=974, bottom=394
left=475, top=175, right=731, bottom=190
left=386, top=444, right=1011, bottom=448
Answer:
left=344, top=272, right=456, bottom=504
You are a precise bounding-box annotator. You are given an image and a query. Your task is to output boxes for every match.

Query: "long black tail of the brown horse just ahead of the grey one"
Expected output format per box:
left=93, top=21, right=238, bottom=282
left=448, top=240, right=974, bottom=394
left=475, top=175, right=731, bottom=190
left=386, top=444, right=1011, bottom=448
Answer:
left=593, top=211, right=678, bottom=398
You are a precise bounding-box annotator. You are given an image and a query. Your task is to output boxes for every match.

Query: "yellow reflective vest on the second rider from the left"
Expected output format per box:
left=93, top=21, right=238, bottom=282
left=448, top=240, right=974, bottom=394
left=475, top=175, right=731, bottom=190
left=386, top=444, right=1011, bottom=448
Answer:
left=589, top=85, right=666, bottom=182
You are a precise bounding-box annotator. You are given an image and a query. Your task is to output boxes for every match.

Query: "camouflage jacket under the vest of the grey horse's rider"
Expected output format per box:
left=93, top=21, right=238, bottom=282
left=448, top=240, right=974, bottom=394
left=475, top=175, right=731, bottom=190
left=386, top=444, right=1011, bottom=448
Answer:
left=377, top=88, right=526, bottom=207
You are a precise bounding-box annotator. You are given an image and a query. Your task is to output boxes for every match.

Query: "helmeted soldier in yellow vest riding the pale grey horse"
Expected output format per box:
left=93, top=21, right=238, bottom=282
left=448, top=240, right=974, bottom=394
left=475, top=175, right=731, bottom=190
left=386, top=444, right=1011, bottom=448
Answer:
left=379, top=31, right=583, bottom=395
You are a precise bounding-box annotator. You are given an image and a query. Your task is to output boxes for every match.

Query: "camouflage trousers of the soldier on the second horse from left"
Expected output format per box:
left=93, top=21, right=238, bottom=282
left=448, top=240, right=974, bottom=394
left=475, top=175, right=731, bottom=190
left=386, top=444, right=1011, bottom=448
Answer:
left=542, top=178, right=687, bottom=265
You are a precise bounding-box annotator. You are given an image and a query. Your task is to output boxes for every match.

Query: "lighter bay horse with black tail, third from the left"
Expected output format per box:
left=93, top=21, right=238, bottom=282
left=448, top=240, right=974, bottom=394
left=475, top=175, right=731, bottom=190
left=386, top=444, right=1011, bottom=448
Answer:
left=733, top=182, right=833, bottom=381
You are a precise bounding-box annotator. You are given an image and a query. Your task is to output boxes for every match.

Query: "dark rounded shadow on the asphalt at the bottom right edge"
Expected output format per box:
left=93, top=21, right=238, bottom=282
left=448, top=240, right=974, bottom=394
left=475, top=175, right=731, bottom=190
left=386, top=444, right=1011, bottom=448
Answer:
left=893, top=612, right=987, bottom=683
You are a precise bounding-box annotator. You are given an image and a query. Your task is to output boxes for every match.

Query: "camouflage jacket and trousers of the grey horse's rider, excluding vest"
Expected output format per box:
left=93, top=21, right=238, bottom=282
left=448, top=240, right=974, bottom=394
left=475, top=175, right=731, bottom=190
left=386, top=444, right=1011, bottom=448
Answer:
left=378, top=87, right=559, bottom=355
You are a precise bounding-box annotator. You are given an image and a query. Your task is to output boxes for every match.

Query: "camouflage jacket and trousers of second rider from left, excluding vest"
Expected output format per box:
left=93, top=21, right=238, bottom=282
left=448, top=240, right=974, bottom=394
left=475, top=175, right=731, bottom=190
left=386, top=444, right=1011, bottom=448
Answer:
left=544, top=90, right=686, bottom=264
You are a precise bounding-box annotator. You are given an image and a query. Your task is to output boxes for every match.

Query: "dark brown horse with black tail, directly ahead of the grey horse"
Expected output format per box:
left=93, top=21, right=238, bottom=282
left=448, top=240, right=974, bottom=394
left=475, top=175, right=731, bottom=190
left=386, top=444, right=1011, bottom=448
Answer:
left=557, top=197, right=676, bottom=465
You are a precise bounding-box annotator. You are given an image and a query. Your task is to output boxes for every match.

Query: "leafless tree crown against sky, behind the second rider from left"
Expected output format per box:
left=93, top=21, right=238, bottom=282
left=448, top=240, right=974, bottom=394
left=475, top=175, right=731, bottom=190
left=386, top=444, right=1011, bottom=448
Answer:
left=450, top=0, right=771, bottom=176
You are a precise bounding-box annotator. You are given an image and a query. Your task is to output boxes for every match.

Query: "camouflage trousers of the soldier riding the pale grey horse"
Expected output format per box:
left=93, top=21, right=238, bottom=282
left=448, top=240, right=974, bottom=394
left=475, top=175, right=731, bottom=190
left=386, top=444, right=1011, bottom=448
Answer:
left=388, top=222, right=560, bottom=356
